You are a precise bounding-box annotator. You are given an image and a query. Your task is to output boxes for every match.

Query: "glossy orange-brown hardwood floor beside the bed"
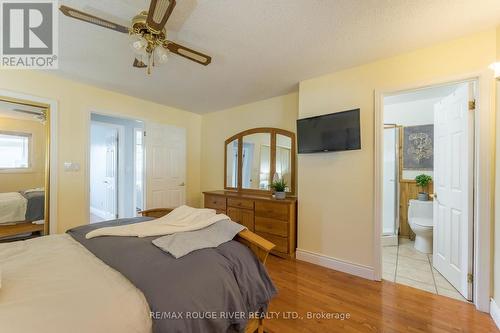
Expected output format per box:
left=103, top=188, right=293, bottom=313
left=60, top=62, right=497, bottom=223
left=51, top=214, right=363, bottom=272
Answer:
left=264, top=256, right=499, bottom=333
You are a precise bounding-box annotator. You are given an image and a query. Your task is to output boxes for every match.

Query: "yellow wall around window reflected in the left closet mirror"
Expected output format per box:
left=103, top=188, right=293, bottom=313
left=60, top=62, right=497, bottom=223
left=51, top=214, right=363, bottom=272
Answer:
left=0, top=118, right=46, bottom=192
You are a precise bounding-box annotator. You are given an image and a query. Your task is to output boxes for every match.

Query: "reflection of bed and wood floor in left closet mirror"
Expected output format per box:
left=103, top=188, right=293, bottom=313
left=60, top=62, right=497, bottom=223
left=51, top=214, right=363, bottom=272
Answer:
left=0, top=188, right=45, bottom=238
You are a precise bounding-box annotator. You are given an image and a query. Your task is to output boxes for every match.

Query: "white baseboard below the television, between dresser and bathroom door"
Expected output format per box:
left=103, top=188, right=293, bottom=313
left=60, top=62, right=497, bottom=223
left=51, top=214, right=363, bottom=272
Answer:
left=296, top=249, right=375, bottom=280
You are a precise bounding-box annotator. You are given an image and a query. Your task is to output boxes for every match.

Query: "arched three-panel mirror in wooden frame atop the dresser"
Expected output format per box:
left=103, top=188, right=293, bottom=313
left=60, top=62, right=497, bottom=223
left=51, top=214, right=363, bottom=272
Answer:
left=224, top=127, right=296, bottom=194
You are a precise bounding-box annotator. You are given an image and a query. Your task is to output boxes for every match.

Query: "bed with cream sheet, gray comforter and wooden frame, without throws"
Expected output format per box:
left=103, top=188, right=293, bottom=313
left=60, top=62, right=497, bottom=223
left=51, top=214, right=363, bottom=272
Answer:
left=0, top=209, right=276, bottom=333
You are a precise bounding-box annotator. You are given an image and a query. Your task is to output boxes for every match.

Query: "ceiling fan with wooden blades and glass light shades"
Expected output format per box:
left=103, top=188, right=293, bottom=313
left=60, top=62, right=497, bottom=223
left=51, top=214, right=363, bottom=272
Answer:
left=59, top=0, right=212, bottom=74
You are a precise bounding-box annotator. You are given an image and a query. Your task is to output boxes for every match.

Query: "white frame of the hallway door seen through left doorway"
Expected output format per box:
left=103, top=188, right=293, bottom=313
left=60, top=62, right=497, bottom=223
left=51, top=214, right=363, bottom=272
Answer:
left=89, top=119, right=125, bottom=218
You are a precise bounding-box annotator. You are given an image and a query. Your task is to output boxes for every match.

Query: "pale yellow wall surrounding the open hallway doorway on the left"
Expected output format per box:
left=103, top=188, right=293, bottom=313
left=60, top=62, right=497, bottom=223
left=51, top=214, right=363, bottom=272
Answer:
left=0, top=70, right=201, bottom=232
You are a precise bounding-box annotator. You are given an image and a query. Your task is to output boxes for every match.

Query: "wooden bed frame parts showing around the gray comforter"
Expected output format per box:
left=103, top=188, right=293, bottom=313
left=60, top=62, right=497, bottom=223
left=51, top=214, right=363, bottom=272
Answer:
left=139, top=208, right=275, bottom=333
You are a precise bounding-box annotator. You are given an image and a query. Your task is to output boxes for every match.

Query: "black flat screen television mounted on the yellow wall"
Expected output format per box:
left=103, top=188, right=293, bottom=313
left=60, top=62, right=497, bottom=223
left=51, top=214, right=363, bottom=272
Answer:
left=297, top=109, right=361, bottom=154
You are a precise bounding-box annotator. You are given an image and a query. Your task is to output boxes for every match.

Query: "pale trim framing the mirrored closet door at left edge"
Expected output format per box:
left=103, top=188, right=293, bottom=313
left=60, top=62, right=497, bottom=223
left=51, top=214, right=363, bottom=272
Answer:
left=0, top=89, right=59, bottom=234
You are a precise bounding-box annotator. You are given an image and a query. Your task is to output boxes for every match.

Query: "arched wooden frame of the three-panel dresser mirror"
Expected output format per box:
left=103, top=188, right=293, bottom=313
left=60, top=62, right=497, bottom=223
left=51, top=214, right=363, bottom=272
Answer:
left=224, top=127, right=297, bottom=195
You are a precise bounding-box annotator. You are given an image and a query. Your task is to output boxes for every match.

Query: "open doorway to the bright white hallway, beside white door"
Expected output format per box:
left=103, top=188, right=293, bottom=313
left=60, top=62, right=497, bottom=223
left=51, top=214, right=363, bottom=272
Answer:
left=89, top=113, right=144, bottom=223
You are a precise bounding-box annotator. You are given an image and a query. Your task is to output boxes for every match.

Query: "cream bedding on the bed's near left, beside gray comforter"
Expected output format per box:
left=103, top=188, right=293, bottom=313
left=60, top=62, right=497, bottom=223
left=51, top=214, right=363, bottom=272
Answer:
left=0, top=234, right=152, bottom=333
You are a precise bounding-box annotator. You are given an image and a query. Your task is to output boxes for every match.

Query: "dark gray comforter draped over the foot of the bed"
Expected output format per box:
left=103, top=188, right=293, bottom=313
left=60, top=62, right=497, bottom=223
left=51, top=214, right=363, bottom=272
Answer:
left=68, top=218, right=276, bottom=333
